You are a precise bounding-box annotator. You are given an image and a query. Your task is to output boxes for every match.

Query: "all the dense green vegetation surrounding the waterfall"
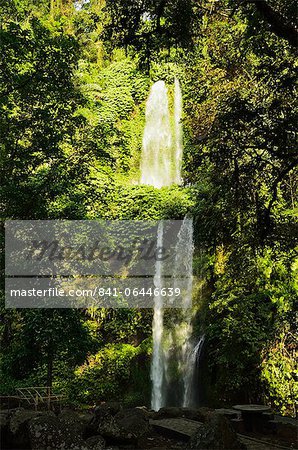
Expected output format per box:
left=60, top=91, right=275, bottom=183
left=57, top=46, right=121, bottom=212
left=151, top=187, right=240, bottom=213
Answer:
left=0, top=0, right=298, bottom=414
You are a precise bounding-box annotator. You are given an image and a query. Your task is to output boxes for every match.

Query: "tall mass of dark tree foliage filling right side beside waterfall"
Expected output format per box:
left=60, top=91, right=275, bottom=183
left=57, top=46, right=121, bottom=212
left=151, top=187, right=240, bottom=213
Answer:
left=180, top=5, right=298, bottom=414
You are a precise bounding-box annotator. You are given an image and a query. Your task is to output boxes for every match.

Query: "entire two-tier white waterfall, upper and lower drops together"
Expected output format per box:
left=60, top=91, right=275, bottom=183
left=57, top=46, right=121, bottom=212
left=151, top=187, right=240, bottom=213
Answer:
left=140, top=79, right=203, bottom=410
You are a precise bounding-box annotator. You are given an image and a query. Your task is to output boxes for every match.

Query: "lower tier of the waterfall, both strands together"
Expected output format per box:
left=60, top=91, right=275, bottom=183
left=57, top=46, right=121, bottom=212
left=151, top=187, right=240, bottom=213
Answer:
left=151, top=218, right=198, bottom=411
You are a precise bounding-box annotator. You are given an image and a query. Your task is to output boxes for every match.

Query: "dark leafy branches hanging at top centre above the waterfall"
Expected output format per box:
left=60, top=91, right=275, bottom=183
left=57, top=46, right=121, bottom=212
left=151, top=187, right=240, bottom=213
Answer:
left=103, top=0, right=196, bottom=72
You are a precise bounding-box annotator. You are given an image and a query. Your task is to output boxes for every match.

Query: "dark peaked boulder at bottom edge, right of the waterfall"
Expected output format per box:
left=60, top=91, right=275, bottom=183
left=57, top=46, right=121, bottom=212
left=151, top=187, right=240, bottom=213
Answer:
left=187, top=413, right=246, bottom=450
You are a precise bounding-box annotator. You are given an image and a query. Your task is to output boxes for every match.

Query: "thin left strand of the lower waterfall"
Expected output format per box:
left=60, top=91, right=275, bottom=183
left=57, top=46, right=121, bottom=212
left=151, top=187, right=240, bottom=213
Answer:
left=151, top=221, right=165, bottom=411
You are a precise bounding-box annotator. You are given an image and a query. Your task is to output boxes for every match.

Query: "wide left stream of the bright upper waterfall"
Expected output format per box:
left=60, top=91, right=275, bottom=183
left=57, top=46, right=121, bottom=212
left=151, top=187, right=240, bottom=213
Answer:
left=141, top=81, right=173, bottom=188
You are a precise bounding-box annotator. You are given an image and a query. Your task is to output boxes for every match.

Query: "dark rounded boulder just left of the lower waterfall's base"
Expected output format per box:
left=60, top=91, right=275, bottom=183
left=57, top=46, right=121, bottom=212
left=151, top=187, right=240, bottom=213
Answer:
left=115, top=408, right=151, bottom=438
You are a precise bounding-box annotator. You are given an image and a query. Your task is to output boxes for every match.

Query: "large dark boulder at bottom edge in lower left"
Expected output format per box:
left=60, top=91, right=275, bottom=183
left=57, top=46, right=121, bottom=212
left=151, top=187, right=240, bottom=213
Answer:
left=29, top=416, right=89, bottom=450
